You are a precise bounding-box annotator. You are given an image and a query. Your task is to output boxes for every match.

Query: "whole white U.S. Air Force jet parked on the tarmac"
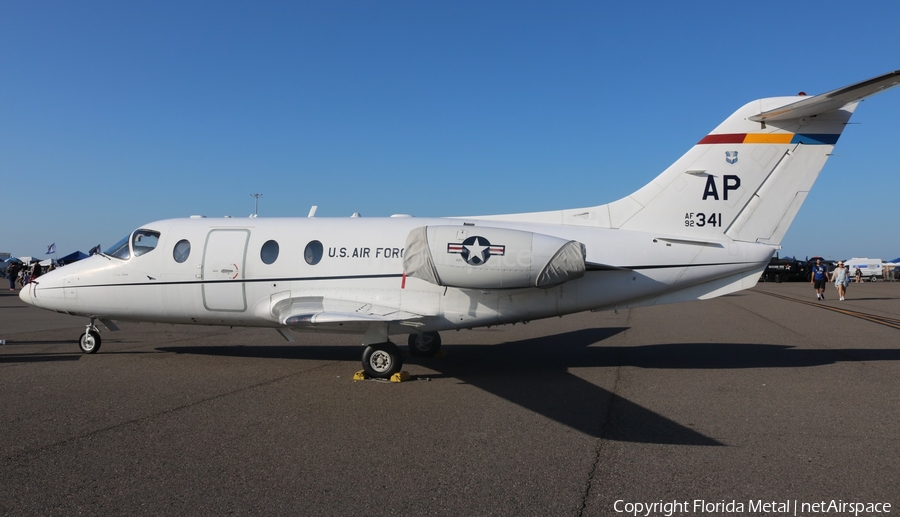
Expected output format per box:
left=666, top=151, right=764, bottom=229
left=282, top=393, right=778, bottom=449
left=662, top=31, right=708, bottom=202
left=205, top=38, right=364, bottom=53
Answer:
left=20, top=70, right=900, bottom=378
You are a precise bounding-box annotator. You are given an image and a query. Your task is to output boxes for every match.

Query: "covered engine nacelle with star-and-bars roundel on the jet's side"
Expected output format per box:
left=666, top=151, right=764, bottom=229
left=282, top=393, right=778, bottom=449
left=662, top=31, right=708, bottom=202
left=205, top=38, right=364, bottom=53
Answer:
left=403, top=226, right=585, bottom=289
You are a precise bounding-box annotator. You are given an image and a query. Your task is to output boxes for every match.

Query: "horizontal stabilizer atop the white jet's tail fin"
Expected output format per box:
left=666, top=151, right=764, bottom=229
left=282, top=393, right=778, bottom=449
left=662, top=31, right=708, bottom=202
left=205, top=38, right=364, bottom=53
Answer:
left=750, top=70, right=900, bottom=122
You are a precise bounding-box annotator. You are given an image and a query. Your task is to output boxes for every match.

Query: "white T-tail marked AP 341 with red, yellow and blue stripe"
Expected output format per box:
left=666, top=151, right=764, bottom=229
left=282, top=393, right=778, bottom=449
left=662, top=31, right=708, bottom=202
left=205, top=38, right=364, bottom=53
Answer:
left=612, top=70, right=900, bottom=245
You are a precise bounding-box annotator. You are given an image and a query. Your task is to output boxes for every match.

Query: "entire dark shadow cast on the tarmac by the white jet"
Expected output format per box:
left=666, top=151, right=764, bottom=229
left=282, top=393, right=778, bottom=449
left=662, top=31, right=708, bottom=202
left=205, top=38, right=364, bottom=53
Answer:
left=156, top=328, right=900, bottom=446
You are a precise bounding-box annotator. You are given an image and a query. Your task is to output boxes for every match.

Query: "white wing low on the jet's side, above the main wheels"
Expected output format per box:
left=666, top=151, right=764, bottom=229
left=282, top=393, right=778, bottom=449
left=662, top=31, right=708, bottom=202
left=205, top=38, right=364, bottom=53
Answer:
left=272, top=296, right=427, bottom=330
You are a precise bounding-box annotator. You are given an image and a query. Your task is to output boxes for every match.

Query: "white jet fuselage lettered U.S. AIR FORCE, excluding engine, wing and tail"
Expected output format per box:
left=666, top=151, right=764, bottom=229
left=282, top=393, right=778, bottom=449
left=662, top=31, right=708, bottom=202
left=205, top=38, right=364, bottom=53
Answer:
left=21, top=217, right=773, bottom=333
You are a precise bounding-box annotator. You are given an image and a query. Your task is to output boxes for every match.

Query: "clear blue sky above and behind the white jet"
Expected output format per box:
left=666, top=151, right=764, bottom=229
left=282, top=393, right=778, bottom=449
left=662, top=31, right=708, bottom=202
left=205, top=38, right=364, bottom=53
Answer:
left=0, top=0, right=900, bottom=259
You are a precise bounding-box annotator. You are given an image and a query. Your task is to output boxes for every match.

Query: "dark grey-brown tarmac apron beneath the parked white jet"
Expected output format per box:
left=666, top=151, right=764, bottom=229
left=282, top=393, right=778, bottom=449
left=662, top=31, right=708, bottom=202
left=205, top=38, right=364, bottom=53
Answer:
left=0, top=283, right=900, bottom=516
